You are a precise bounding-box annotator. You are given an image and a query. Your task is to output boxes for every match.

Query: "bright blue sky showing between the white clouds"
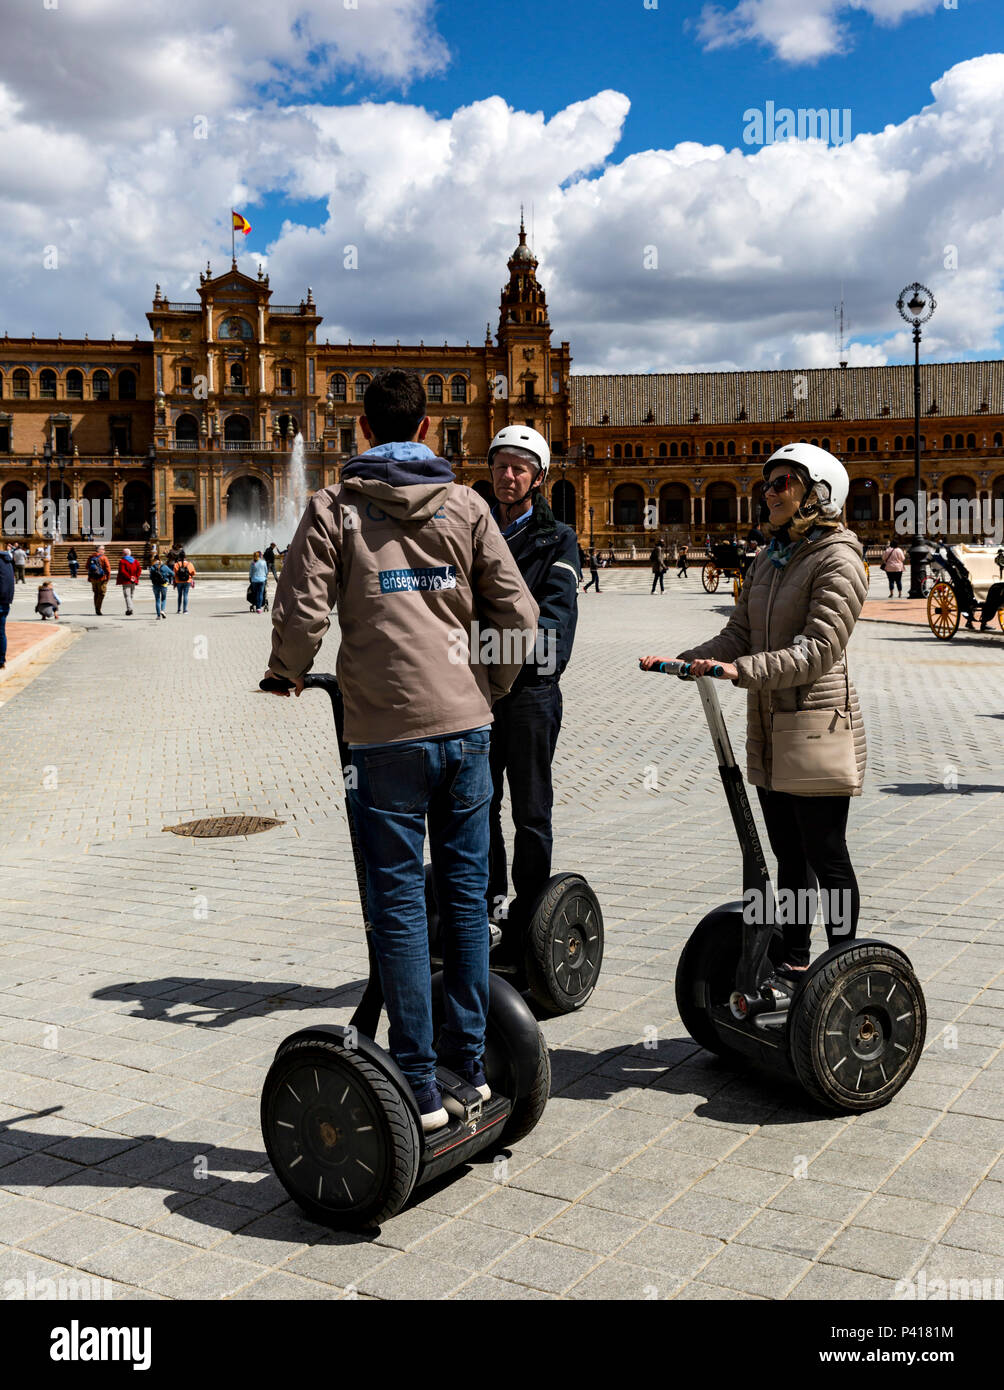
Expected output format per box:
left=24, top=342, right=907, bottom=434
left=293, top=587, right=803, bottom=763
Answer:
left=249, top=0, right=1004, bottom=246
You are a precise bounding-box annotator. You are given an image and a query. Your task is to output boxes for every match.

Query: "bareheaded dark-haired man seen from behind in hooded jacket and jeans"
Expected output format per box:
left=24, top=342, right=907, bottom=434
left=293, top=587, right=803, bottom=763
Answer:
left=261, top=368, right=537, bottom=1131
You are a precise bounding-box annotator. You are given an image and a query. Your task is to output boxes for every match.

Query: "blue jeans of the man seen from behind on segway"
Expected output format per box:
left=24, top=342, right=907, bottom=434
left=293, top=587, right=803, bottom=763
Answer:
left=349, top=728, right=491, bottom=1090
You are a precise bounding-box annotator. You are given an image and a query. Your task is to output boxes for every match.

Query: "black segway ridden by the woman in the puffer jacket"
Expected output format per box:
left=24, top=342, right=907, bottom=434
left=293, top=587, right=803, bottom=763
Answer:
left=642, top=662, right=928, bottom=1113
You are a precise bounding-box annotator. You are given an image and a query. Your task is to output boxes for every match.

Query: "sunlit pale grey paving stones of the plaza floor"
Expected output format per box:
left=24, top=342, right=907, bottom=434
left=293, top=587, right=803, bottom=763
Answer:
left=0, top=570, right=1004, bottom=1300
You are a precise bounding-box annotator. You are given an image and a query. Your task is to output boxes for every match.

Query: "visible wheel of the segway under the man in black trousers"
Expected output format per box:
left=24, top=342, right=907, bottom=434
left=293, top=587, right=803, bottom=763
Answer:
left=526, top=873, right=604, bottom=1013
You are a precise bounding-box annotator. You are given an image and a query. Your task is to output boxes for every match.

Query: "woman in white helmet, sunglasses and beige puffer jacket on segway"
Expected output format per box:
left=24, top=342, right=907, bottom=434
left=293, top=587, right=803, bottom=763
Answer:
left=642, top=443, right=868, bottom=980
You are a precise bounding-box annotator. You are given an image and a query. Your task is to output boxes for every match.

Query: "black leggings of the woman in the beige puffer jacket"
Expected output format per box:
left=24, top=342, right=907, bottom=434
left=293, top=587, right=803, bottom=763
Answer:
left=756, top=787, right=861, bottom=965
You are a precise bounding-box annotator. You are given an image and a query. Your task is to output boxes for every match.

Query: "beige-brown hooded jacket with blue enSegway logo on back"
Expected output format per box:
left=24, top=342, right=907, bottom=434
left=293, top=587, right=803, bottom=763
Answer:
left=268, top=460, right=538, bottom=744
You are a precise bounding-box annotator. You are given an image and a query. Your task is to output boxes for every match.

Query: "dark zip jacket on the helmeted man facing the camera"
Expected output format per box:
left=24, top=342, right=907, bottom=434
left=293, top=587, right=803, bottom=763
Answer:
left=495, top=492, right=583, bottom=692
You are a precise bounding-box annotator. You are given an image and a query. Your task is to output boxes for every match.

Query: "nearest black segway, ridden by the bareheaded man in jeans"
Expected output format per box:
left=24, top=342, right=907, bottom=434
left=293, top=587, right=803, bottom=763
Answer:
left=250, top=676, right=551, bottom=1230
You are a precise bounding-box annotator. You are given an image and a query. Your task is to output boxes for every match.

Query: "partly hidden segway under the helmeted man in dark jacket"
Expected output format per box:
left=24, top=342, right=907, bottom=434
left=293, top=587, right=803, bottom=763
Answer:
left=426, top=865, right=604, bottom=1013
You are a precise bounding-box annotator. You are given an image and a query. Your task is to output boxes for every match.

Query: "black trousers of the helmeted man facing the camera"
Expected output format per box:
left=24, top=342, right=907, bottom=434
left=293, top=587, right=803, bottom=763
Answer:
left=488, top=681, right=562, bottom=929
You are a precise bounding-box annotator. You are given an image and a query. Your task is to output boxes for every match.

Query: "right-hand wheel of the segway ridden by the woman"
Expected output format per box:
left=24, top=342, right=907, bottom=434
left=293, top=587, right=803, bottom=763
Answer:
left=788, top=942, right=928, bottom=1112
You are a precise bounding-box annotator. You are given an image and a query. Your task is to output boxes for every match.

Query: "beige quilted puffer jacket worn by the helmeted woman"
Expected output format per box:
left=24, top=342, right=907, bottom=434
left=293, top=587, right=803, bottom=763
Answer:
left=680, top=527, right=868, bottom=795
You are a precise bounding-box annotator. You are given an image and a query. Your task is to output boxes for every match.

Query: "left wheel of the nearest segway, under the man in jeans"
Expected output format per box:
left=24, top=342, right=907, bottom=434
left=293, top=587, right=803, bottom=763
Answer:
left=261, top=1038, right=421, bottom=1230
